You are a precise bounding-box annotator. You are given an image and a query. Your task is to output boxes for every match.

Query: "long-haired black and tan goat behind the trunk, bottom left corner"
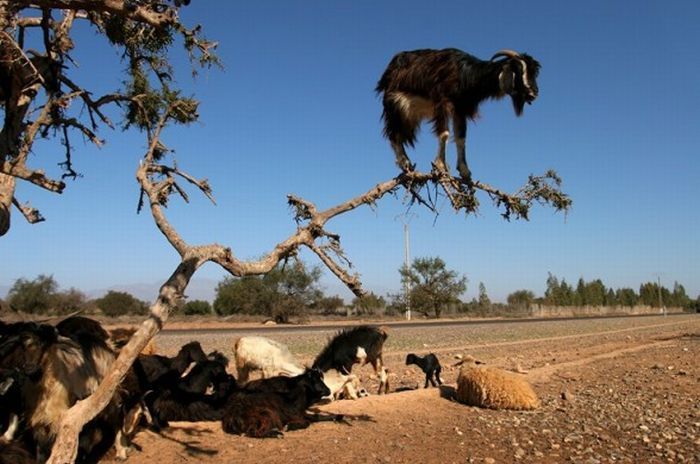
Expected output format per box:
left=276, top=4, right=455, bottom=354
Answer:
left=0, top=318, right=126, bottom=462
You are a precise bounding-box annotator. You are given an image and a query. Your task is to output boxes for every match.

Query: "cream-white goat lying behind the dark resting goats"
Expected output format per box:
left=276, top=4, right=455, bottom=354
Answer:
left=233, top=337, right=304, bottom=385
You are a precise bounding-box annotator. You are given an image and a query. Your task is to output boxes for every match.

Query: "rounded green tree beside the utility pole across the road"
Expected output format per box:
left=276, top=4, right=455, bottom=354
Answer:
left=399, top=257, right=467, bottom=318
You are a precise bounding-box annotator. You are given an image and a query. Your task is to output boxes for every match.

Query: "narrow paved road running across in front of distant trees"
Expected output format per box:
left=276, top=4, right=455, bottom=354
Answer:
left=161, top=313, right=687, bottom=336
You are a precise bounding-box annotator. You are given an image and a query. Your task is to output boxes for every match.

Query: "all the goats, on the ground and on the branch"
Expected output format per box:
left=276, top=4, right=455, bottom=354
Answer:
left=0, top=42, right=540, bottom=464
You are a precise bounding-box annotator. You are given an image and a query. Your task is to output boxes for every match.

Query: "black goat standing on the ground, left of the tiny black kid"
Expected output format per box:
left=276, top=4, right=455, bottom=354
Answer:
left=312, top=325, right=389, bottom=395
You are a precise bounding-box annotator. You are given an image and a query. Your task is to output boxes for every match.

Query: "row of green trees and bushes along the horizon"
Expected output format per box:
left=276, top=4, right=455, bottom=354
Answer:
left=0, top=257, right=700, bottom=323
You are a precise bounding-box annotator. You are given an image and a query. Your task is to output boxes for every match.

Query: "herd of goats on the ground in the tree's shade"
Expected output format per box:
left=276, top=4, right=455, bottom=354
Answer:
left=0, top=316, right=441, bottom=464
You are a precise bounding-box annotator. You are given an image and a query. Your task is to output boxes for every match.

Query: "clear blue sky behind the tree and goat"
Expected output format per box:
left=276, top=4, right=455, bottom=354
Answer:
left=0, top=1, right=700, bottom=300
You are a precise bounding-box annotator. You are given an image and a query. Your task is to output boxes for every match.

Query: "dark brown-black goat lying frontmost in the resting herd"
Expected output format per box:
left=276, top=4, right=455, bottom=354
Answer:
left=221, top=369, right=342, bottom=438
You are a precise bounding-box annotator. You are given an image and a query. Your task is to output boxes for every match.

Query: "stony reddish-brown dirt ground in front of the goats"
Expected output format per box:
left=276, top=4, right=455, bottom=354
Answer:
left=101, top=316, right=700, bottom=464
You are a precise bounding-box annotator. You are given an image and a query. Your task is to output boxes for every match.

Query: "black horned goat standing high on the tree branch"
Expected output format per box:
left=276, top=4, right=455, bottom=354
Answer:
left=376, top=48, right=540, bottom=184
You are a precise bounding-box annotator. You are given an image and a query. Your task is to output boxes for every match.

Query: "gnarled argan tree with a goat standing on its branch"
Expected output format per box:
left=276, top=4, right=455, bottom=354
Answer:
left=0, top=0, right=571, bottom=464
